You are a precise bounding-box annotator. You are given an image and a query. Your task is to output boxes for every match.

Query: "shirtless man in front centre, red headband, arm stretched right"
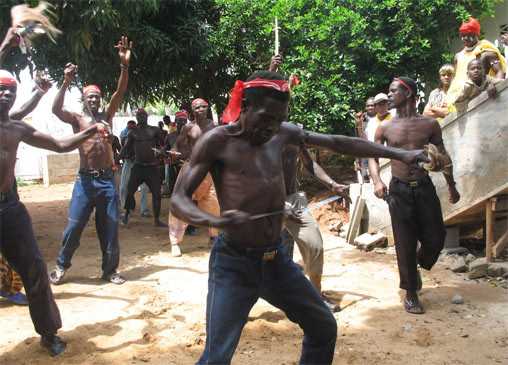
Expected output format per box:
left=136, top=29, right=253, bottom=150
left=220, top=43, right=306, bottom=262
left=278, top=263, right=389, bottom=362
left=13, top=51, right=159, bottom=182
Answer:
left=171, top=71, right=423, bottom=364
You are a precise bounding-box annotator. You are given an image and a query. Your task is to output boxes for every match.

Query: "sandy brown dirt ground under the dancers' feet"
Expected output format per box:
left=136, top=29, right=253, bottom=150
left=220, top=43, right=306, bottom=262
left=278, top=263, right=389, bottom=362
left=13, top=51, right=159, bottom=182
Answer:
left=0, top=184, right=508, bottom=365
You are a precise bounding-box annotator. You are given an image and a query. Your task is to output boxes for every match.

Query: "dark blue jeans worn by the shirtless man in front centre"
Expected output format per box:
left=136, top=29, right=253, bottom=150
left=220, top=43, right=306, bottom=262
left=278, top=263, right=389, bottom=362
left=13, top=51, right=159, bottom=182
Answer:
left=197, top=235, right=337, bottom=365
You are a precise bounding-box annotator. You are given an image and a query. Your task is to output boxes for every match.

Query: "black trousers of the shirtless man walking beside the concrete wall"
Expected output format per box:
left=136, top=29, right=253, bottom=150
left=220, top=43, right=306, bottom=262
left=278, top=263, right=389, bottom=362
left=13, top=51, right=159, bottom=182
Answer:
left=388, top=177, right=446, bottom=290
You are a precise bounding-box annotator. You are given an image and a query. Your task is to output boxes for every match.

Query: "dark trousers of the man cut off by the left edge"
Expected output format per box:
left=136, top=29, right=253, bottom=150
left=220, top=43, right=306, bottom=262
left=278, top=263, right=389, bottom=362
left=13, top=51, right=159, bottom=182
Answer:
left=0, top=198, right=62, bottom=336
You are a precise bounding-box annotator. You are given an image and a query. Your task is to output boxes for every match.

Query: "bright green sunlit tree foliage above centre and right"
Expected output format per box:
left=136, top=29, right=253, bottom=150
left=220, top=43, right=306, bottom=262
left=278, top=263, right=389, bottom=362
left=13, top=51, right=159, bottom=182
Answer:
left=211, top=0, right=497, bottom=133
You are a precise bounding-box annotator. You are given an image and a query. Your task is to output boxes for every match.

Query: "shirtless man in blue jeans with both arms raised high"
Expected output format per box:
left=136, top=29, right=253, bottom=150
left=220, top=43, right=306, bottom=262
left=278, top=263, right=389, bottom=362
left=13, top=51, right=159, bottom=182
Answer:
left=50, top=37, right=132, bottom=284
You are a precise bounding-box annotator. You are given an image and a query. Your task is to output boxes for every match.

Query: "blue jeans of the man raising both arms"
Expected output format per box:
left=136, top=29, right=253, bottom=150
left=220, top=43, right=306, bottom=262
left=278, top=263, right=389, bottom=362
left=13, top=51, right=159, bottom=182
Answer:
left=56, top=172, right=120, bottom=276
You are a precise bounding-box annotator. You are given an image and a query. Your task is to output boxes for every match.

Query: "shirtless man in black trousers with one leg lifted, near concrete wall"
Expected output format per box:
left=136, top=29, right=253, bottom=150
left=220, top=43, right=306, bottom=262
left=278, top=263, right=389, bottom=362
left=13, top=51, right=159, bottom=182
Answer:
left=369, top=77, right=460, bottom=314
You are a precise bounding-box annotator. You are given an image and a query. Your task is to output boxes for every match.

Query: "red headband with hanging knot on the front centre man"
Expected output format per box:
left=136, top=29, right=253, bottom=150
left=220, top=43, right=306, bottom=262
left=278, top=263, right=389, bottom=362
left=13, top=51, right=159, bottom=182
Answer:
left=222, top=78, right=289, bottom=124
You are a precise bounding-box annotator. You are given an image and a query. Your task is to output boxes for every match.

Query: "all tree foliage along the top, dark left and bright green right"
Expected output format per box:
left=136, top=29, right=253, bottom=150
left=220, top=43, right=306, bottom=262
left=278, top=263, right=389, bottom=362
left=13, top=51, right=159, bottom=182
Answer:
left=0, top=0, right=499, bottom=133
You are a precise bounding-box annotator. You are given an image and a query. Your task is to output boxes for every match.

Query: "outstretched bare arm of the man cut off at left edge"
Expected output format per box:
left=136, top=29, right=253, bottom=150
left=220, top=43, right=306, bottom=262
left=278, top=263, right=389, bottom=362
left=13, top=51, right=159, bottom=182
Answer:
left=23, top=124, right=99, bottom=153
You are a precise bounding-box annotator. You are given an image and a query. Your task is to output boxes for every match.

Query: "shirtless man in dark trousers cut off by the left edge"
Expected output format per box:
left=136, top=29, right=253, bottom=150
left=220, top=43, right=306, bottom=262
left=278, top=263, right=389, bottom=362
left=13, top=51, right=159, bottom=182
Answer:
left=0, top=70, right=104, bottom=356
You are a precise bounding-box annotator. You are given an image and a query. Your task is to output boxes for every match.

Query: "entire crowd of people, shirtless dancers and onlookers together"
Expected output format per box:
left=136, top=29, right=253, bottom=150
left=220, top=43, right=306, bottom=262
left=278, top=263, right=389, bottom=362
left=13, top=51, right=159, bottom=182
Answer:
left=0, top=12, right=506, bottom=364
